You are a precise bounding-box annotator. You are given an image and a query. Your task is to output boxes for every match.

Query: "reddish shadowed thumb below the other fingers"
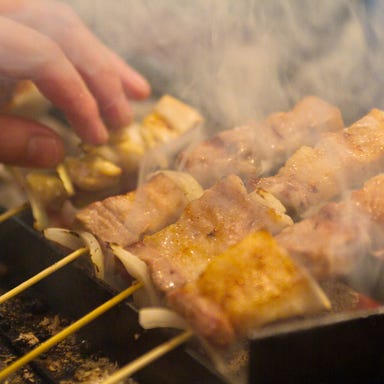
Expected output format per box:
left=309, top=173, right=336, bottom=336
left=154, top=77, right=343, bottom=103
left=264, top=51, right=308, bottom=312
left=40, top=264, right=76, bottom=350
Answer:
left=0, top=116, right=64, bottom=168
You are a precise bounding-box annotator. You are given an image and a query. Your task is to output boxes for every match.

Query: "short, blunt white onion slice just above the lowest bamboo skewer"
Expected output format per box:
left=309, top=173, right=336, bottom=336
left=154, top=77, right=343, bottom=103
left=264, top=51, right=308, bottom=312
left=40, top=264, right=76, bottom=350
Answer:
left=139, top=307, right=188, bottom=329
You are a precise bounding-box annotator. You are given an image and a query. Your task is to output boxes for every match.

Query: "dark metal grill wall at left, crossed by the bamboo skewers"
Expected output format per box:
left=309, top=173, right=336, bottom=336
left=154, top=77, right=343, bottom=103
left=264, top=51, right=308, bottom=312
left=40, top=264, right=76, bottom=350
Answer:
left=0, top=210, right=223, bottom=384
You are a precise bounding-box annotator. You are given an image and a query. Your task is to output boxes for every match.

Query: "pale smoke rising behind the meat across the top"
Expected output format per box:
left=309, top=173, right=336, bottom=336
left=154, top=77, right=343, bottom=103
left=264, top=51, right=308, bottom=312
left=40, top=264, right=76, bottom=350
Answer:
left=66, top=0, right=384, bottom=128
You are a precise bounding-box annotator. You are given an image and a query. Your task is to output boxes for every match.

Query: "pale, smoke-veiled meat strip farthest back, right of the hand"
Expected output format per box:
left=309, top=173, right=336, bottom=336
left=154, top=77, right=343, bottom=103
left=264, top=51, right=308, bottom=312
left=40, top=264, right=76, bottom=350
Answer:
left=180, top=96, right=343, bottom=187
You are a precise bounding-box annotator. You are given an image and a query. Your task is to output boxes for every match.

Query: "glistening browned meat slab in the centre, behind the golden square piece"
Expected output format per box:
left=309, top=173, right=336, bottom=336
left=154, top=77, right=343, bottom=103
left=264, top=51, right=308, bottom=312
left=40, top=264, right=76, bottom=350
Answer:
left=129, top=175, right=291, bottom=292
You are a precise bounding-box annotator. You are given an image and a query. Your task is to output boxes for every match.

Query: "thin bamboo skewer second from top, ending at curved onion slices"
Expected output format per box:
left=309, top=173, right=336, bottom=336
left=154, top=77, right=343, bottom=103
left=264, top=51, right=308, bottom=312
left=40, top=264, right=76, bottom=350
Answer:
left=0, top=247, right=88, bottom=305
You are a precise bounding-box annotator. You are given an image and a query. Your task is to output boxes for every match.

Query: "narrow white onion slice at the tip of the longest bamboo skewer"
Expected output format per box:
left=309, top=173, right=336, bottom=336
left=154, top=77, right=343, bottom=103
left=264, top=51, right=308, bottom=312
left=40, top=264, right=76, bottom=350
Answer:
left=111, top=244, right=159, bottom=305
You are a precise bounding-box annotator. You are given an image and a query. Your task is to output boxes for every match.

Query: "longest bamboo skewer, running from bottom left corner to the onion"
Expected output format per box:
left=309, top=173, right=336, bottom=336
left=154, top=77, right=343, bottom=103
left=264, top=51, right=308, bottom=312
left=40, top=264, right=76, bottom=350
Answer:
left=0, top=282, right=143, bottom=382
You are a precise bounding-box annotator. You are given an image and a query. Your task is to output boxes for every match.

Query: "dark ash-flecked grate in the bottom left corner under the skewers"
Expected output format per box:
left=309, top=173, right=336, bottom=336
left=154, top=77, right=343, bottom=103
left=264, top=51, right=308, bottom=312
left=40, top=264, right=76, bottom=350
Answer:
left=0, top=294, right=116, bottom=384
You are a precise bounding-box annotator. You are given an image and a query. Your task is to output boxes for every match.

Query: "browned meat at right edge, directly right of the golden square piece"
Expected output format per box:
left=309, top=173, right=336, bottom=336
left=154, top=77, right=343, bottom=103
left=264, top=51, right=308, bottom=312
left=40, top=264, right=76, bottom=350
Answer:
left=276, top=174, right=384, bottom=278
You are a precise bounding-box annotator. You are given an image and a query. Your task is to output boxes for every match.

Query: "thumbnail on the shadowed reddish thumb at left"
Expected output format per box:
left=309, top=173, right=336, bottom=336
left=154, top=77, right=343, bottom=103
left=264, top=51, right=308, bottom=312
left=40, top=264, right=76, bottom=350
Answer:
left=26, top=136, right=64, bottom=167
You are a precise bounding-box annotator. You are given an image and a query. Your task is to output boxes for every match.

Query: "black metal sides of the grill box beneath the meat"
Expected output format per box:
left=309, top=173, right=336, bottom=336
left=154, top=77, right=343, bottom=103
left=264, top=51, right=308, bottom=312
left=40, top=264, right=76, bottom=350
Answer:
left=0, top=208, right=384, bottom=384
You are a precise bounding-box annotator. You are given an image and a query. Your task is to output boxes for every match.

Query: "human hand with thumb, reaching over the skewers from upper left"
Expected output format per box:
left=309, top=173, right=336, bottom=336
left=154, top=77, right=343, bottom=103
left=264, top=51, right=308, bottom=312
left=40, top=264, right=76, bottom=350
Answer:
left=0, top=0, right=150, bottom=167
